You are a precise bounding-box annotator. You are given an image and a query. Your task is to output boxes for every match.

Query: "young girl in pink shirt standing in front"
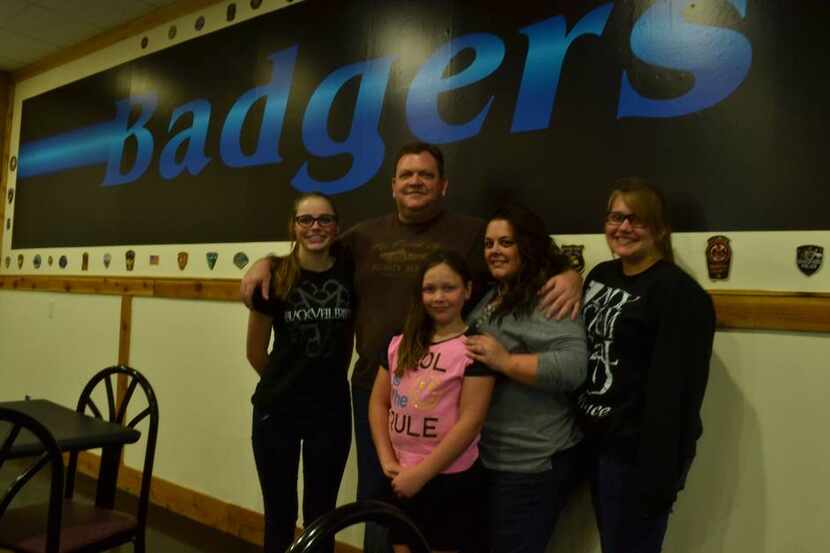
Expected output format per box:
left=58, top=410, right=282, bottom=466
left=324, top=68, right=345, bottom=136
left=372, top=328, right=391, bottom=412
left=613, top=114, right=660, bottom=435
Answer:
left=369, top=251, right=494, bottom=553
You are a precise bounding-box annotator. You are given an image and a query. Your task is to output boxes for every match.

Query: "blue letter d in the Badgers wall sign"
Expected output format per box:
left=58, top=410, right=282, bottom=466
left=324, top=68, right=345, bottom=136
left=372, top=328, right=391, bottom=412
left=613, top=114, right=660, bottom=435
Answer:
left=219, top=45, right=297, bottom=167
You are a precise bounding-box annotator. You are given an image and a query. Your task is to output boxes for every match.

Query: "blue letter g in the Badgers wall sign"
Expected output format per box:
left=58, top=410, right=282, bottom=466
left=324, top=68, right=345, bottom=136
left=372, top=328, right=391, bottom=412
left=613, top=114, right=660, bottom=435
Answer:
left=291, top=57, right=392, bottom=194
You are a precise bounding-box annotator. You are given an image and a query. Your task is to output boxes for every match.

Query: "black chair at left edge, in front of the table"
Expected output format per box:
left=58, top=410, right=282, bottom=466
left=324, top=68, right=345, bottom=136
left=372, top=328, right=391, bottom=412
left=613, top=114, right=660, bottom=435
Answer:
left=0, top=407, right=63, bottom=553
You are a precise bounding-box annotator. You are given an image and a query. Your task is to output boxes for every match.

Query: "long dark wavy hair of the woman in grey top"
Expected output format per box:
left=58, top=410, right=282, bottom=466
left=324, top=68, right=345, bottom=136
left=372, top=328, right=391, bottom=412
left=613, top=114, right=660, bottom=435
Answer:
left=488, top=204, right=570, bottom=321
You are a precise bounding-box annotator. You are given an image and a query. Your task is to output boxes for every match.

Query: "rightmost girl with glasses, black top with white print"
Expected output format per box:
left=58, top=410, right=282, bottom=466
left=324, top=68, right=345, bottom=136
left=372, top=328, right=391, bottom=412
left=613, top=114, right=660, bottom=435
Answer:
left=577, top=179, right=715, bottom=553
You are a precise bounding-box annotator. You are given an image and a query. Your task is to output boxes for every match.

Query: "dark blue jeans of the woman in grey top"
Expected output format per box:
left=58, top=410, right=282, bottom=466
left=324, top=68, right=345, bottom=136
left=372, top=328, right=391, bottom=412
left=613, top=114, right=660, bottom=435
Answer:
left=485, top=447, right=579, bottom=553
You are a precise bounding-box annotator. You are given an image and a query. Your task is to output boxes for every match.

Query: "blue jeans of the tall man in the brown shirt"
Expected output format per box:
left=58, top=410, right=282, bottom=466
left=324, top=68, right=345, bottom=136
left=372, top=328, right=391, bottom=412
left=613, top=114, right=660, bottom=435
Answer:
left=352, top=387, right=392, bottom=553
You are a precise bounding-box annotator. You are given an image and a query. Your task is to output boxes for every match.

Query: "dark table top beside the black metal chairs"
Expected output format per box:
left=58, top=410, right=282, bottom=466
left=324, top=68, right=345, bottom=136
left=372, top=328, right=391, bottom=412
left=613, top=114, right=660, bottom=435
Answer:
left=0, top=399, right=141, bottom=459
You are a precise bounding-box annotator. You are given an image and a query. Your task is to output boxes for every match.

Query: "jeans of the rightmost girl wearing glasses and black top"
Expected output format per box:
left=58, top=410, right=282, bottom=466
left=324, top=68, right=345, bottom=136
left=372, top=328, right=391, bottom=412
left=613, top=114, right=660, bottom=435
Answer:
left=590, top=453, right=688, bottom=553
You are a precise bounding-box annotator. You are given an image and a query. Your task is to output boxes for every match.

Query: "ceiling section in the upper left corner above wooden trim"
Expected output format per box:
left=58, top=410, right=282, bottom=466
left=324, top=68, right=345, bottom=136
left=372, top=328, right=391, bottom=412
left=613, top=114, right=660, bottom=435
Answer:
left=0, top=0, right=178, bottom=71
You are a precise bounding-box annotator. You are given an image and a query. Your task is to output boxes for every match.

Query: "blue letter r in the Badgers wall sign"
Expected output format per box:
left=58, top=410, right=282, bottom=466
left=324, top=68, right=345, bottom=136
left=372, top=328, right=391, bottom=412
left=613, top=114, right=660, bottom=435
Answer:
left=510, top=4, right=613, bottom=133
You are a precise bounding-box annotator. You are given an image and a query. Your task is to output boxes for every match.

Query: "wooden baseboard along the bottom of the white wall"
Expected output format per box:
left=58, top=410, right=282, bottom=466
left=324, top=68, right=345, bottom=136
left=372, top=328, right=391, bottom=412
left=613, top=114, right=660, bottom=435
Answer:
left=78, top=452, right=362, bottom=553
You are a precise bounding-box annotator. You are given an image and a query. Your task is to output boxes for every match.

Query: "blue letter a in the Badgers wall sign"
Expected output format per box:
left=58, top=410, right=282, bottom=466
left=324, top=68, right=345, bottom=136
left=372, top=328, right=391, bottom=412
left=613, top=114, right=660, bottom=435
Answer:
left=159, top=100, right=210, bottom=180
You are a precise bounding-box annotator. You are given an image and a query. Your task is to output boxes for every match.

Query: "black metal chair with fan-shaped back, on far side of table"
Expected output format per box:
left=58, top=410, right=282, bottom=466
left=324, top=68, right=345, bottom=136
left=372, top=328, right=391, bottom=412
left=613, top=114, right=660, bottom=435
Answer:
left=0, top=365, right=159, bottom=553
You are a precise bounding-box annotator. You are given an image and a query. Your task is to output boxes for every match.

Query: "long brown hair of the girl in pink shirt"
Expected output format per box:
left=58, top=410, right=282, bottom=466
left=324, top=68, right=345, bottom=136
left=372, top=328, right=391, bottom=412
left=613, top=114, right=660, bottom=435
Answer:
left=395, top=250, right=471, bottom=376
